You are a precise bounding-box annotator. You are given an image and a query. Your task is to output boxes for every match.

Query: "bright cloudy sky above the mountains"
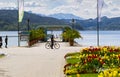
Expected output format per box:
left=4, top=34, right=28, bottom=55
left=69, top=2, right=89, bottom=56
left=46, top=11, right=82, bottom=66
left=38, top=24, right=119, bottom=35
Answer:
left=0, top=0, right=120, bottom=19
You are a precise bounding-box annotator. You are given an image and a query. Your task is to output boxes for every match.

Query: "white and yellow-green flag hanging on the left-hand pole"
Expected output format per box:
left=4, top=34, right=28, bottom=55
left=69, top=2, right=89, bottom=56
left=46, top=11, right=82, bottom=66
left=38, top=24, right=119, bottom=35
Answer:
left=18, top=0, right=24, bottom=22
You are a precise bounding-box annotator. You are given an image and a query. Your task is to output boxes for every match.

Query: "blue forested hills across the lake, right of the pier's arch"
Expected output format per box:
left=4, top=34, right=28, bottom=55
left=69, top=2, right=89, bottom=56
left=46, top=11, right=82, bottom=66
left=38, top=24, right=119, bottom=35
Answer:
left=63, top=16, right=120, bottom=30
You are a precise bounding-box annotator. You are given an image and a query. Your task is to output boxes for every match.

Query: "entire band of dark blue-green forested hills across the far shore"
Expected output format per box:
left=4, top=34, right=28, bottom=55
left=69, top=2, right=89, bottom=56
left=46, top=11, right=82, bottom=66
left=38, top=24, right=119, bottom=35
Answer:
left=0, top=10, right=120, bottom=31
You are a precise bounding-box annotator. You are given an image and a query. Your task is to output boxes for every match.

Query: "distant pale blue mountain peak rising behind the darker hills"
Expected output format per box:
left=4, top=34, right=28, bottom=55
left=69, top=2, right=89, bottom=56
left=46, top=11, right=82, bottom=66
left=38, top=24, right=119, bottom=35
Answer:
left=48, top=13, right=83, bottom=20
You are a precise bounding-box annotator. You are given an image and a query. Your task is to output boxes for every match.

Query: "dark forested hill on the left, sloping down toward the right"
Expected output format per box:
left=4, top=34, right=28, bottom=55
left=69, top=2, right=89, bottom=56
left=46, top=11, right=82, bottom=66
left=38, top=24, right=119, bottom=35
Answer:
left=0, top=10, right=66, bottom=30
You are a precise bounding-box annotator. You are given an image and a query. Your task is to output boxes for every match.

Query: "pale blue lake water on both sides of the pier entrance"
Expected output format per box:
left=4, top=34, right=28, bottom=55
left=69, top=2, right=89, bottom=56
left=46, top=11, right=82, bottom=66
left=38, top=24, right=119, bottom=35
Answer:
left=0, top=31, right=120, bottom=47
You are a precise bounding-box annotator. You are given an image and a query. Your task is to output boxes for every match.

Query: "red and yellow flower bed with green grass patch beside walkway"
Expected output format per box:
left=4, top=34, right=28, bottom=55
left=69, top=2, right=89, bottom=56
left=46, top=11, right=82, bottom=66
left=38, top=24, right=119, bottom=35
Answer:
left=64, top=46, right=120, bottom=77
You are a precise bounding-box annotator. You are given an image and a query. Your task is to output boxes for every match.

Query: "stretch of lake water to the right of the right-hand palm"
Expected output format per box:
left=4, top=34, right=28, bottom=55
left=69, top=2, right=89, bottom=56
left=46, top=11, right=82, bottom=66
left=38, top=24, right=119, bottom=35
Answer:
left=76, top=31, right=120, bottom=46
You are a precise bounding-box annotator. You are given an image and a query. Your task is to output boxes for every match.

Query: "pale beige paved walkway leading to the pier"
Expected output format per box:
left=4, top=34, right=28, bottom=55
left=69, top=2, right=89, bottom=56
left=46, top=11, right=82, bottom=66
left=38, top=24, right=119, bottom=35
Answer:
left=0, top=43, right=80, bottom=77
